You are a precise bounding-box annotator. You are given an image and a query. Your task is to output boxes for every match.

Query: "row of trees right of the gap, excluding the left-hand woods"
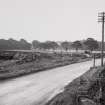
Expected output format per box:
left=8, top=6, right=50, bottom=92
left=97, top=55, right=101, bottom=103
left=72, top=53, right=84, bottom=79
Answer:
left=32, top=38, right=101, bottom=51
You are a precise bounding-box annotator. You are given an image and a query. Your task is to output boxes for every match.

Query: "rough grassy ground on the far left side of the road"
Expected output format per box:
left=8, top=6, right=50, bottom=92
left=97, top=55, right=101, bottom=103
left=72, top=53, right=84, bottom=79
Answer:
left=0, top=51, right=89, bottom=80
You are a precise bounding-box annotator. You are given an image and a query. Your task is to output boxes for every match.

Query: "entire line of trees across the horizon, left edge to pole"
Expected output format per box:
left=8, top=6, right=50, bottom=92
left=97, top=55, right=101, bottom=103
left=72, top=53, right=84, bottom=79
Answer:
left=0, top=38, right=101, bottom=51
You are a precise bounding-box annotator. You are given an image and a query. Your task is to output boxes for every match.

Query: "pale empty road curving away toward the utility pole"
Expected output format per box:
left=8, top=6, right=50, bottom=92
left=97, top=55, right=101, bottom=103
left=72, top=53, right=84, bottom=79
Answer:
left=0, top=60, right=100, bottom=105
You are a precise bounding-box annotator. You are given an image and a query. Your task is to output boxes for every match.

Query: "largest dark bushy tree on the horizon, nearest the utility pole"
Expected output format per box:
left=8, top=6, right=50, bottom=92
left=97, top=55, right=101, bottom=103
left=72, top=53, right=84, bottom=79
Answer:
left=84, top=38, right=99, bottom=51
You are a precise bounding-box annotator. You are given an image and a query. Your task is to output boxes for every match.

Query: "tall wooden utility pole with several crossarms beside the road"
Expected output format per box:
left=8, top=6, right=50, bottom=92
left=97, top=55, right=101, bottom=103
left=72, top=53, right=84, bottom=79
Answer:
left=98, top=12, right=105, bottom=66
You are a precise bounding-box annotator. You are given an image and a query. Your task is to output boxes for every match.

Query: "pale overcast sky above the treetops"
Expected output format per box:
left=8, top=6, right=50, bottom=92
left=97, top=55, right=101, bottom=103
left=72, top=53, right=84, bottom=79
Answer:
left=0, top=0, right=105, bottom=42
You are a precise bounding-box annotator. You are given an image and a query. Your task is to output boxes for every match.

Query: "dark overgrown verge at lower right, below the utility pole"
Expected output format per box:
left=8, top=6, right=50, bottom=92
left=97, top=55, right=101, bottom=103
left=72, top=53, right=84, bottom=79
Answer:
left=46, top=67, right=105, bottom=105
